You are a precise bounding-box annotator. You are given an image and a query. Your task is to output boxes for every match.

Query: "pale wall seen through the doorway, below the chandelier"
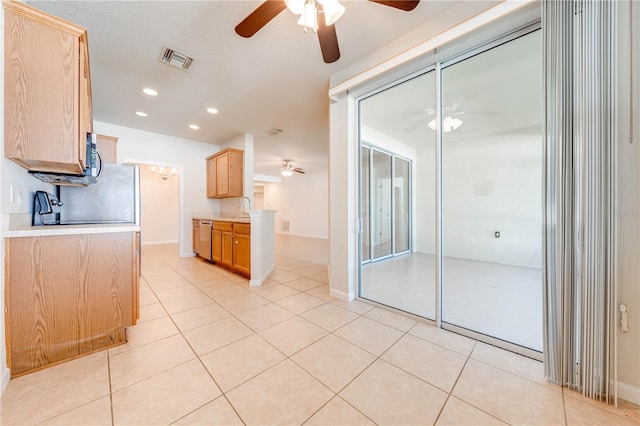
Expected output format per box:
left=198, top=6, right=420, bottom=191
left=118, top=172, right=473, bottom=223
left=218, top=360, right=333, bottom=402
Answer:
left=140, top=164, right=181, bottom=245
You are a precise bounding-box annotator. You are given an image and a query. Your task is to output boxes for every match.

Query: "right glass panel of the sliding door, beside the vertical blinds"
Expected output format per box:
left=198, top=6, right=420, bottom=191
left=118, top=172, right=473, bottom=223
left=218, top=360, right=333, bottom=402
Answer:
left=442, top=31, right=542, bottom=351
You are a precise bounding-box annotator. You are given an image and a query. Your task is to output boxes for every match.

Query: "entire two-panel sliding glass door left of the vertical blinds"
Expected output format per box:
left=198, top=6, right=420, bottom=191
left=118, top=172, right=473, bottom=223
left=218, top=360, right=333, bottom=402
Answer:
left=359, top=30, right=542, bottom=355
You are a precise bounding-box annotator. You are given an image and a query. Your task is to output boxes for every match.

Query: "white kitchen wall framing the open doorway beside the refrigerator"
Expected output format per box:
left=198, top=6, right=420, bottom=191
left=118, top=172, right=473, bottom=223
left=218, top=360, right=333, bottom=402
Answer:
left=93, top=121, right=220, bottom=256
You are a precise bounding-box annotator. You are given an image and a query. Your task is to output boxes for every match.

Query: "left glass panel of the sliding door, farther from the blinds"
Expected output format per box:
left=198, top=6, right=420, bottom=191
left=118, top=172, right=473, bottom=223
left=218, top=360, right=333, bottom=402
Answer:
left=359, top=71, right=435, bottom=318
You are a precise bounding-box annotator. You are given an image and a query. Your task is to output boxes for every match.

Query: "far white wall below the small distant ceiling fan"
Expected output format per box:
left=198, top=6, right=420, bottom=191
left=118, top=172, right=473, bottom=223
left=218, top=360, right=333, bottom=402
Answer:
left=264, top=169, right=329, bottom=238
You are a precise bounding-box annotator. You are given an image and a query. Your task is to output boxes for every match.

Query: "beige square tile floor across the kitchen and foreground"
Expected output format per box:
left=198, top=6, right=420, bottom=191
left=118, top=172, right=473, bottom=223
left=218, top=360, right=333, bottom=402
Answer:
left=0, top=240, right=640, bottom=425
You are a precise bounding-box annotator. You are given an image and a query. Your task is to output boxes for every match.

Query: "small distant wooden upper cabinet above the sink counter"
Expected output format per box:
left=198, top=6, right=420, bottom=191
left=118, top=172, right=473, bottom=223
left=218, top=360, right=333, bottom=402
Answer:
left=207, top=148, right=244, bottom=198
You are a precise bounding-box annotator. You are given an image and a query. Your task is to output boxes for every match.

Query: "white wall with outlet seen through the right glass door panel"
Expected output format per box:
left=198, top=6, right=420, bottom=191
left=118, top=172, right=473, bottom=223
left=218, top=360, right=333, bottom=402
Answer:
left=442, top=132, right=542, bottom=269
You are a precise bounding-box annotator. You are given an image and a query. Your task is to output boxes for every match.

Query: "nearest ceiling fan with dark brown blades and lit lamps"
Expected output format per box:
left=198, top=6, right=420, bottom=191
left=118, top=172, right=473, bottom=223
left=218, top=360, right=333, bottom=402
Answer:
left=236, top=0, right=420, bottom=64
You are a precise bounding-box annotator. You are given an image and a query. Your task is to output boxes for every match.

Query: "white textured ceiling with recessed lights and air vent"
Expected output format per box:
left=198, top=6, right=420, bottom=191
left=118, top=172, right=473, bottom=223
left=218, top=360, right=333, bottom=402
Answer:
left=28, top=0, right=500, bottom=174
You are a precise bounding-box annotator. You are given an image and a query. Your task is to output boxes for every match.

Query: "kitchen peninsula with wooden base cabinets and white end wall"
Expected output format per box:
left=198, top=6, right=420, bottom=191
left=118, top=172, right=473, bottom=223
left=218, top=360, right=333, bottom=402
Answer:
left=191, top=210, right=275, bottom=286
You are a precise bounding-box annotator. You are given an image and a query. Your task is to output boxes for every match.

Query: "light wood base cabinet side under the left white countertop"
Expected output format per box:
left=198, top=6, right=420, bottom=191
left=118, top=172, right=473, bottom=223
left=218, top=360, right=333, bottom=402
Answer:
left=5, top=232, right=140, bottom=377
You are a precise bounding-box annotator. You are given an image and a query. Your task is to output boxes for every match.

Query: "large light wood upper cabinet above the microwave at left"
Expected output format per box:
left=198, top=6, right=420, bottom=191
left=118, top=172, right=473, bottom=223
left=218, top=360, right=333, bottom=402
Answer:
left=2, top=1, right=93, bottom=174
